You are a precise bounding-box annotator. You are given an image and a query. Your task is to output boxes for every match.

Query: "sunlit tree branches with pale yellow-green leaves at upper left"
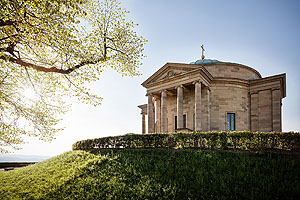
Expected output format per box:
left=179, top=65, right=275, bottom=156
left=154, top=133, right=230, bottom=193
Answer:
left=0, top=0, right=146, bottom=153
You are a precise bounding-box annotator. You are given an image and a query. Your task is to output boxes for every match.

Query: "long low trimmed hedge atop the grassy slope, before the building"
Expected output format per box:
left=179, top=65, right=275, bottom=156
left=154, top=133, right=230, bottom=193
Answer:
left=73, top=131, right=300, bottom=152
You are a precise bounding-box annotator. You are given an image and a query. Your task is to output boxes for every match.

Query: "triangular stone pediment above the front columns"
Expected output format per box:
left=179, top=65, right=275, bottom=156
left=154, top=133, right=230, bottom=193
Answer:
left=142, top=63, right=199, bottom=86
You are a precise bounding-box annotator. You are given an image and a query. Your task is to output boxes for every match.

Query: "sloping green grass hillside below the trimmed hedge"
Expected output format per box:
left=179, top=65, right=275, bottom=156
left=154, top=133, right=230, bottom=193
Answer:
left=0, top=150, right=300, bottom=200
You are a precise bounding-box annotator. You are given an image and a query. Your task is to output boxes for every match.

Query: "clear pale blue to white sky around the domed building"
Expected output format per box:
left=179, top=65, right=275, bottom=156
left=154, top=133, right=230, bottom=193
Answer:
left=4, top=0, right=300, bottom=156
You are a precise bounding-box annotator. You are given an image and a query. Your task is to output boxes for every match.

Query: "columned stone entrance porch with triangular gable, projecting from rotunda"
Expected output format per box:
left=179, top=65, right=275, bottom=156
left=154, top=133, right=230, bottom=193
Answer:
left=139, top=65, right=212, bottom=133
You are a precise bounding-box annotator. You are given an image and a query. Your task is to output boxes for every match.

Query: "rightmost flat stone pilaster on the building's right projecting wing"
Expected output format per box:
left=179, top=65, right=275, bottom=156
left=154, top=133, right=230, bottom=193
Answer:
left=272, top=89, right=281, bottom=132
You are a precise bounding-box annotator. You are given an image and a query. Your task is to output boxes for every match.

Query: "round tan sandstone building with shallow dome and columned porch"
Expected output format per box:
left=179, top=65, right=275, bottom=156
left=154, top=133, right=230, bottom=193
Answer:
left=139, top=60, right=286, bottom=133
